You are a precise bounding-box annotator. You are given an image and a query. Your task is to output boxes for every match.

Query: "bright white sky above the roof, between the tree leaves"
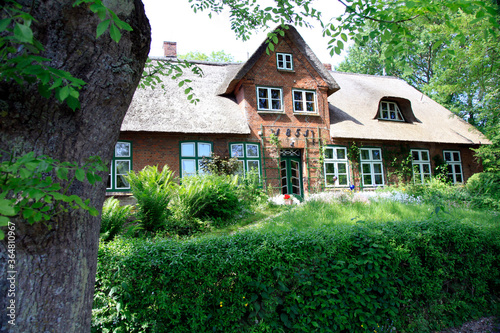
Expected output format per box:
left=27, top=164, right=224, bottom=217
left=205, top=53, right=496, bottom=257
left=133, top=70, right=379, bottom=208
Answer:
left=143, top=0, right=343, bottom=65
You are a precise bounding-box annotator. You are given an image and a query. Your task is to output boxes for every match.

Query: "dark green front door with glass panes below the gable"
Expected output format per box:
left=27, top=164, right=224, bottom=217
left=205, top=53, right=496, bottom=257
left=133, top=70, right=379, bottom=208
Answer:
left=280, top=149, right=302, bottom=197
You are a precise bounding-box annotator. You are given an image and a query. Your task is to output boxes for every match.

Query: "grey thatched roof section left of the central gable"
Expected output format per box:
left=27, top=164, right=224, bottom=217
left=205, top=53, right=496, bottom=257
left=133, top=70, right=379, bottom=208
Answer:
left=121, top=59, right=250, bottom=134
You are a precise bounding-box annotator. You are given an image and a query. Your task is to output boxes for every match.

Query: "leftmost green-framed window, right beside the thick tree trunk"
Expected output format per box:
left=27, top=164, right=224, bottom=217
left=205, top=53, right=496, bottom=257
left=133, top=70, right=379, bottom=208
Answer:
left=106, top=141, right=132, bottom=192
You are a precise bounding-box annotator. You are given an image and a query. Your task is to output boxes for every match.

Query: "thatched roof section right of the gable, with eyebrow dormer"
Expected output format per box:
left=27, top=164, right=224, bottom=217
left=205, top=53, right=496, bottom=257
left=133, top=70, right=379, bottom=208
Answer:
left=328, top=72, right=490, bottom=144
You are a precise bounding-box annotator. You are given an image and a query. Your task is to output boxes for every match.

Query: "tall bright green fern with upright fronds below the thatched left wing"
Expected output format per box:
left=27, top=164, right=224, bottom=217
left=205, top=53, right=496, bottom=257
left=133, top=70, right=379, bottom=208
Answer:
left=127, top=166, right=176, bottom=232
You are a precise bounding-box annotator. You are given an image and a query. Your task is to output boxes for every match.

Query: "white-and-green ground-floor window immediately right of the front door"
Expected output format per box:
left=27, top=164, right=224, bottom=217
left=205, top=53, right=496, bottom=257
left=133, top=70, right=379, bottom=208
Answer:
left=324, top=146, right=349, bottom=187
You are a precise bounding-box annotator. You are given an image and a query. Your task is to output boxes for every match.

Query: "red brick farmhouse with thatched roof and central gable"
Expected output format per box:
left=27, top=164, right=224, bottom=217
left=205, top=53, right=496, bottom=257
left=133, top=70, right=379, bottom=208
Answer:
left=108, top=26, right=490, bottom=196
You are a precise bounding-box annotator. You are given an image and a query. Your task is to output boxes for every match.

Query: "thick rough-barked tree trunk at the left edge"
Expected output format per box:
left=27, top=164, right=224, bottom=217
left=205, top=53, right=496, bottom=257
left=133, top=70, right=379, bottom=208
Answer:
left=0, top=0, right=150, bottom=333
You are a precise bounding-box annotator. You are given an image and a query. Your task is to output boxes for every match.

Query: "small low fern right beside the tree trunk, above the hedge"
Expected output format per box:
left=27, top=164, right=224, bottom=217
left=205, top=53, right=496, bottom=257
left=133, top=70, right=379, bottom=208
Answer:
left=100, top=197, right=133, bottom=241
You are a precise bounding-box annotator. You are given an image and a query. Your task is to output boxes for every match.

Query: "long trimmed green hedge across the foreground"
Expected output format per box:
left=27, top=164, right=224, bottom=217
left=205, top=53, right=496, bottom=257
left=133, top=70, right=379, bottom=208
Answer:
left=93, top=218, right=500, bottom=332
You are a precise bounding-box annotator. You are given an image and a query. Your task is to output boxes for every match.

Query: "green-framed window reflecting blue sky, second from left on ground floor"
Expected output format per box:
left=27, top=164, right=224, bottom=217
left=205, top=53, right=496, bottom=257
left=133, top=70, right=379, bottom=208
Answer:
left=180, top=141, right=212, bottom=177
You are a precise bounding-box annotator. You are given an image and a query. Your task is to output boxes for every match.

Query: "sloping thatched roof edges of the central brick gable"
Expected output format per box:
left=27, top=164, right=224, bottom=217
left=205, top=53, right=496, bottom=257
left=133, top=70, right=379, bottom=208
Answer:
left=218, top=25, right=340, bottom=95
